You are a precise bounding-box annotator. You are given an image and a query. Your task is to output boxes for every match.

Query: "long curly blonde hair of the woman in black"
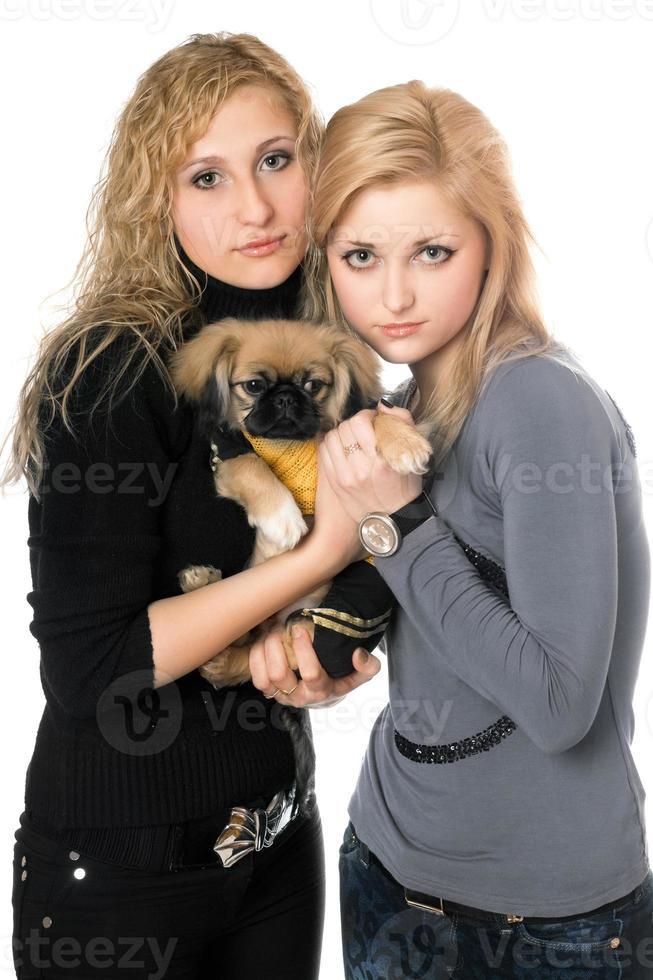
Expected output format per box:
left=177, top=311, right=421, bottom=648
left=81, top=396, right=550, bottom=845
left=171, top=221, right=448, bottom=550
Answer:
left=0, top=31, right=324, bottom=500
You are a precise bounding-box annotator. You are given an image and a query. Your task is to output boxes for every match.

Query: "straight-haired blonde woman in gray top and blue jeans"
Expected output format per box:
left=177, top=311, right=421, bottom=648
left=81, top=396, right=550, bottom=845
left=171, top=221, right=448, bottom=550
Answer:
left=247, top=80, right=653, bottom=980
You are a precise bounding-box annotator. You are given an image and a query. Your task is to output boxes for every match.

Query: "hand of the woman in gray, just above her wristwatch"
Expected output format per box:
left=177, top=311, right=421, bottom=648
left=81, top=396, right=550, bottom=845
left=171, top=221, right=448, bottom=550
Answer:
left=315, top=403, right=422, bottom=526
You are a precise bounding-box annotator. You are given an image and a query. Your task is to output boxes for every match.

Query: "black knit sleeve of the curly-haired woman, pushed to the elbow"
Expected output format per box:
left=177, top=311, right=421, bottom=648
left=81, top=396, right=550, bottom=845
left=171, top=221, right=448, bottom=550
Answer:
left=27, top=343, right=182, bottom=718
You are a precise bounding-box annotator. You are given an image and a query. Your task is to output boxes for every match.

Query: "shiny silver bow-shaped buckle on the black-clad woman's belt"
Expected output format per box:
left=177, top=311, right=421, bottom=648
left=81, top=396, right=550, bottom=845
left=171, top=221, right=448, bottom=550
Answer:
left=213, top=783, right=296, bottom=868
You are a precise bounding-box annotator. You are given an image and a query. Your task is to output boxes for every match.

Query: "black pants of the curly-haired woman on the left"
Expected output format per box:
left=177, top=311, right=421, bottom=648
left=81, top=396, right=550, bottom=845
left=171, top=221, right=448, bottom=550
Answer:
left=12, top=808, right=325, bottom=980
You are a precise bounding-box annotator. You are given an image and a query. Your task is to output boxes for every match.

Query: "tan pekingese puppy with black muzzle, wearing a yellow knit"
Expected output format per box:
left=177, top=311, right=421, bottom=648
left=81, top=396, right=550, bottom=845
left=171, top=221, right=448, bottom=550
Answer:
left=170, top=318, right=432, bottom=688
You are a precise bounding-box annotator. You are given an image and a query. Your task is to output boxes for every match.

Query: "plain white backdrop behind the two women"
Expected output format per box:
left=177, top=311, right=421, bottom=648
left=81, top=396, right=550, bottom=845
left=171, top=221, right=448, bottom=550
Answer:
left=0, top=0, right=653, bottom=980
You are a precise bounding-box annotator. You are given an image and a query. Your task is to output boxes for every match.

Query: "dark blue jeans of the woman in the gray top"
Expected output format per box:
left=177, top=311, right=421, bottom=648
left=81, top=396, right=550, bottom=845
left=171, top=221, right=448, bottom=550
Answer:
left=339, top=821, right=653, bottom=980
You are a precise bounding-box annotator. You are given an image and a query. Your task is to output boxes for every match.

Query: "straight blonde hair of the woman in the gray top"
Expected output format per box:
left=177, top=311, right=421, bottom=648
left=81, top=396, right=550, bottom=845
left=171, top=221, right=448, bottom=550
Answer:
left=304, top=79, right=573, bottom=465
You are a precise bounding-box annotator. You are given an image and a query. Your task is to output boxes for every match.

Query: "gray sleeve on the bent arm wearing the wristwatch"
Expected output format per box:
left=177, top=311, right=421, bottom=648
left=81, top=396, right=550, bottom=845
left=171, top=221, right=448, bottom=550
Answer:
left=376, top=357, right=648, bottom=753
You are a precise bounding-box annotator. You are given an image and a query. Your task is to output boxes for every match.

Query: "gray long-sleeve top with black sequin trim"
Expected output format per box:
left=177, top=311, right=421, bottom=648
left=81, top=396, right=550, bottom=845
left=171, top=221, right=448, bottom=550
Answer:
left=349, top=353, right=650, bottom=916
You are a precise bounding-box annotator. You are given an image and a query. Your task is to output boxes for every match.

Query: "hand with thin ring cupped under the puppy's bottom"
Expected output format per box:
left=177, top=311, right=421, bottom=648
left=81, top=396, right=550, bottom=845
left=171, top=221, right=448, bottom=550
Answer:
left=249, top=626, right=381, bottom=708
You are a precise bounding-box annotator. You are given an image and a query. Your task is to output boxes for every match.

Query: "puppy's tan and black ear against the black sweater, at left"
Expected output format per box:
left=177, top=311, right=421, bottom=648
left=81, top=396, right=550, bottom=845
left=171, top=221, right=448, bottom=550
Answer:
left=170, top=319, right=240, bottom=435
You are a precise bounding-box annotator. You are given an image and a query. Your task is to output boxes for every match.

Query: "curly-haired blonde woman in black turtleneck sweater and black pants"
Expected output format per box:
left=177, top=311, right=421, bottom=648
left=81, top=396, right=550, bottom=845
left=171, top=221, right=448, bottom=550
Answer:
left=4, top=32, right=378, bottom=980
